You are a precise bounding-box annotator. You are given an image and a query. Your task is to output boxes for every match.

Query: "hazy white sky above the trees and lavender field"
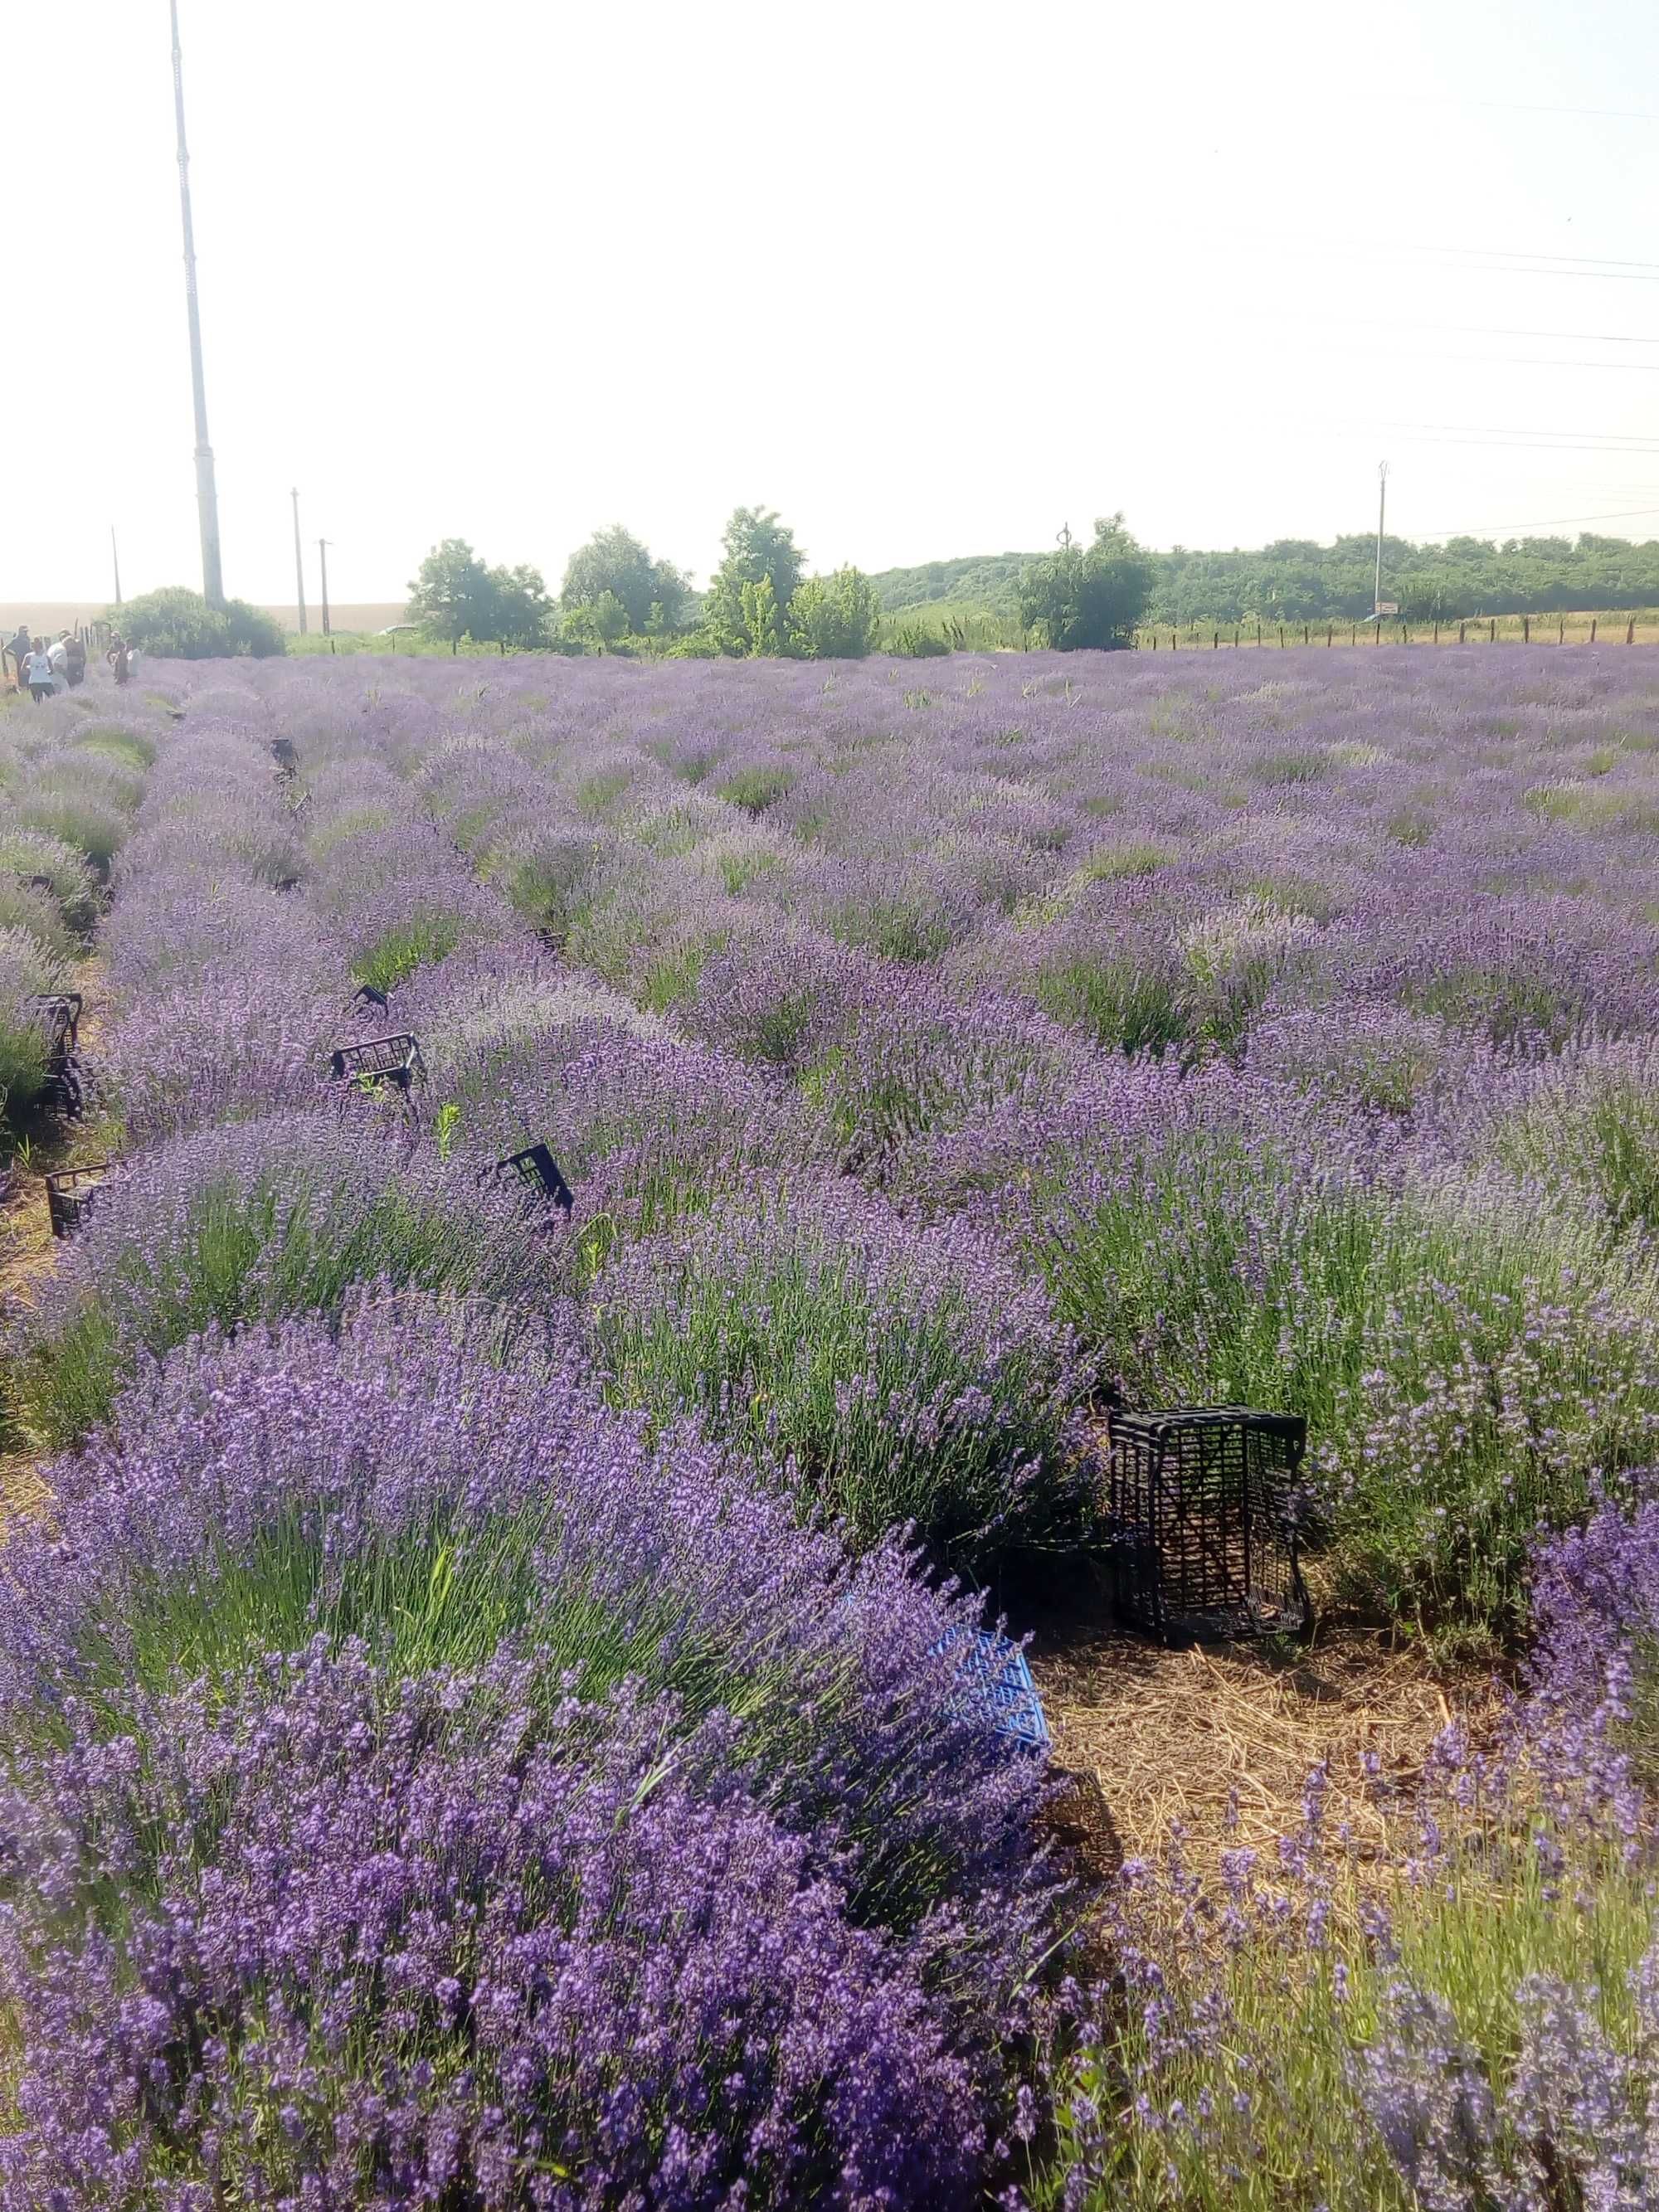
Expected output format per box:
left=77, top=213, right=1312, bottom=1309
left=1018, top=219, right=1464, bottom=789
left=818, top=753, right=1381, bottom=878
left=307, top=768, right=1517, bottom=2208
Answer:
left=0, top=0, right=1659, bottom=606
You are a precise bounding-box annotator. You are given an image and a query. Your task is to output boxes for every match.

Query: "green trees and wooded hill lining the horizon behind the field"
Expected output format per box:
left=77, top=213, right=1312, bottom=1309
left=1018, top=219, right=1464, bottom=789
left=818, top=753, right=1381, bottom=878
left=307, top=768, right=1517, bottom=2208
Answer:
left=94, top=507, right=1659, bottom=659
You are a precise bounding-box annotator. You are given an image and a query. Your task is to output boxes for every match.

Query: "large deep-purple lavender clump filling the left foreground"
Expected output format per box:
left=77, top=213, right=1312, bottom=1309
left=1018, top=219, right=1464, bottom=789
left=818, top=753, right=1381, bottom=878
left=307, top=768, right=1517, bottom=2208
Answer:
left=0, top=1299, right=1055, bottom=2212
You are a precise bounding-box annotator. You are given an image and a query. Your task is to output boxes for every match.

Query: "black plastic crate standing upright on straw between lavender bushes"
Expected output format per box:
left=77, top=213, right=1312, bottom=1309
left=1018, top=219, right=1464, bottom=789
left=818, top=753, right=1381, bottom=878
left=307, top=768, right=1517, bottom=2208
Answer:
left=1111, top=1405, right=1311, bottom=1644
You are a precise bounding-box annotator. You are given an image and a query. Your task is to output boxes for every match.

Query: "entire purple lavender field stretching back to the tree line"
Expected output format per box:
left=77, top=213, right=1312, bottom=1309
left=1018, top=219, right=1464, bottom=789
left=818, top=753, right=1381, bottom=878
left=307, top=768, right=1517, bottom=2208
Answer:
left=0, top=648, right=1659, bottom=2212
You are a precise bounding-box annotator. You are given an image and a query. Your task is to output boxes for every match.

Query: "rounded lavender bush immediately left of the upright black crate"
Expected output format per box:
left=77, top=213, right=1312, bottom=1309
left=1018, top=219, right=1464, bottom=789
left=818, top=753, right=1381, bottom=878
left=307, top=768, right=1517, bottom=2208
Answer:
left=593, top=1186, right=1086, bottom=1559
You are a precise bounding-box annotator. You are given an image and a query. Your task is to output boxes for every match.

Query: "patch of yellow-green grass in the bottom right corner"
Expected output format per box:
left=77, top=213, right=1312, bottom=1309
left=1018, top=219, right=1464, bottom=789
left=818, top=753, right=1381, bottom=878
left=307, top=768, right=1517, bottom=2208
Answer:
left=1035, top=1807, right=1652, bottom=2212
